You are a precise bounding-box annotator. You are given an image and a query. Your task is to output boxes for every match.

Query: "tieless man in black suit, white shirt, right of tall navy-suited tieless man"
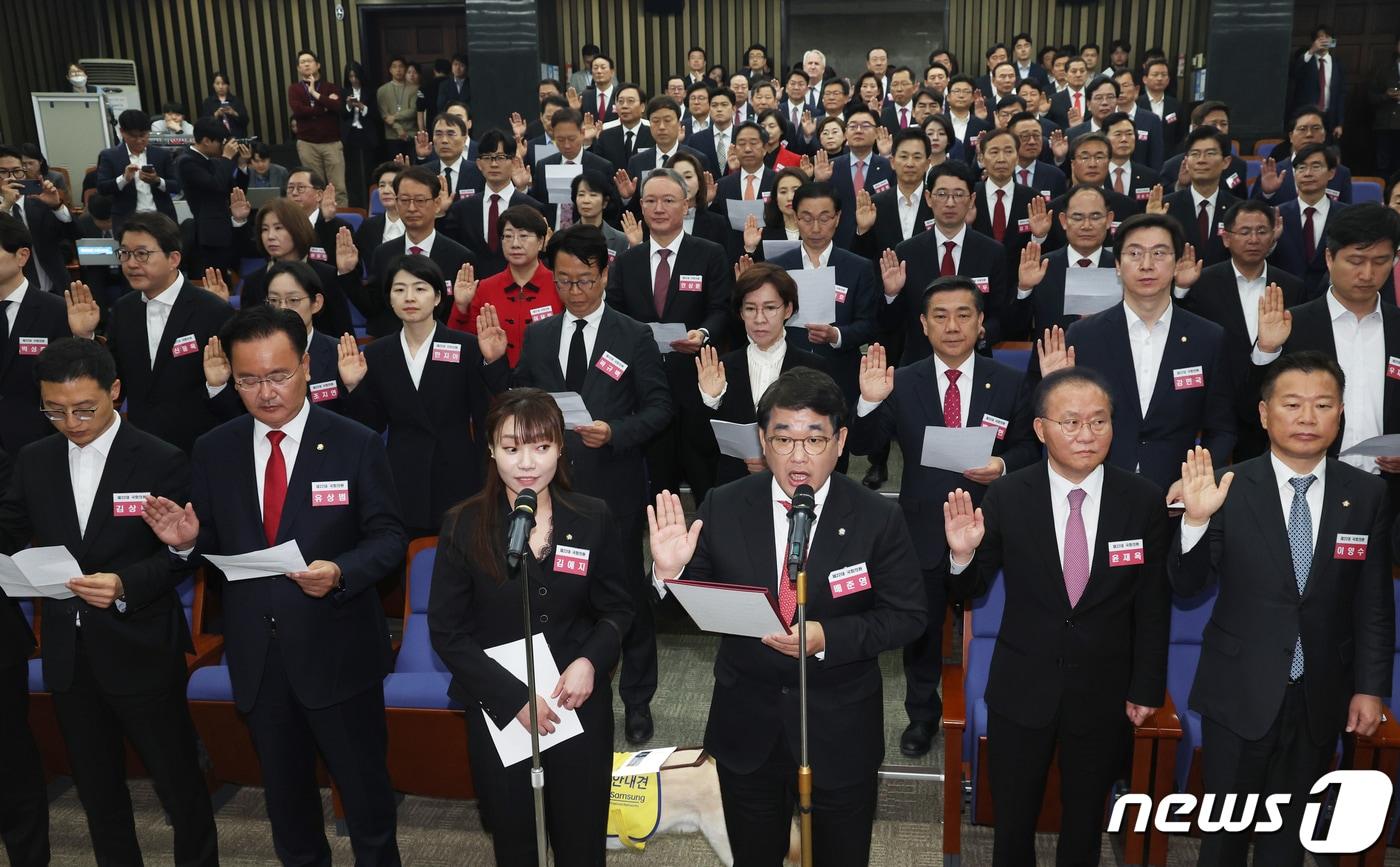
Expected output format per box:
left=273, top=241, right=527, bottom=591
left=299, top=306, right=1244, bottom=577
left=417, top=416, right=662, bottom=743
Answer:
left=1177, top=199, right=1305, bottom=462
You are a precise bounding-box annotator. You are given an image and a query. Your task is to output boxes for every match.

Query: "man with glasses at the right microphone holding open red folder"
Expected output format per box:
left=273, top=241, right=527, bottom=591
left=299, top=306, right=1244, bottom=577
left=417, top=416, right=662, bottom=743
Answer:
left=647, top=368, right=927, bottom=867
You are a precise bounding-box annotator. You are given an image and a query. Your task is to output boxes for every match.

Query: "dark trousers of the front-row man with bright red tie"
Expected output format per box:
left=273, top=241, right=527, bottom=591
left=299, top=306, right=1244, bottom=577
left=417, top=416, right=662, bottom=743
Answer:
left=246, top=639, right=400, bottom=867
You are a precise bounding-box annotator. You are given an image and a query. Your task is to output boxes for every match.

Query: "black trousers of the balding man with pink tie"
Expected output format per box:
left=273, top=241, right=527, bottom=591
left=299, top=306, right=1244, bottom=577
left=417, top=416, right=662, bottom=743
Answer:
left=987, top=709, right=1133, bottom=867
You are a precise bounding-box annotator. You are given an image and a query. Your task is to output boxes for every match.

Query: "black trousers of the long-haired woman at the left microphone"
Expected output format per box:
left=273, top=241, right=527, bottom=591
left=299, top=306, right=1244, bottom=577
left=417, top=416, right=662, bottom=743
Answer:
left=466, top=671, right=613, bottom=867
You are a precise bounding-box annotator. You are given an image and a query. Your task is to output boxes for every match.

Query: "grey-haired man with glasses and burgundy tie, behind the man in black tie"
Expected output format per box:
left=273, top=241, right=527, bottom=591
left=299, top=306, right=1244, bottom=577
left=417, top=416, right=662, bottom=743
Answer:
left=606, top=168, right=734, bottom=504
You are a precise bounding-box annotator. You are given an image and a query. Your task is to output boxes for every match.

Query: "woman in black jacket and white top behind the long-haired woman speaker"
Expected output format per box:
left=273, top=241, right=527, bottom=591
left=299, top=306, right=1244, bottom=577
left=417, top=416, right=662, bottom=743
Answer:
left=339, top=255, right=510, bottom=536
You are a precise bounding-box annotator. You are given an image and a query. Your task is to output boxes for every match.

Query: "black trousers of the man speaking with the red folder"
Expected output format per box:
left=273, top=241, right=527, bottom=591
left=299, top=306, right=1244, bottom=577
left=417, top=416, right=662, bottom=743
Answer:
left=717, top=720, right=879, bottom=867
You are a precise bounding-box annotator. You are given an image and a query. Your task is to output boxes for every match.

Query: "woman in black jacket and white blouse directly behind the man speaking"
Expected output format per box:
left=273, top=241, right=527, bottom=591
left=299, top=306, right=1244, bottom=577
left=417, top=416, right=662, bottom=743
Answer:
left=696, top=263, right=830, bottom=501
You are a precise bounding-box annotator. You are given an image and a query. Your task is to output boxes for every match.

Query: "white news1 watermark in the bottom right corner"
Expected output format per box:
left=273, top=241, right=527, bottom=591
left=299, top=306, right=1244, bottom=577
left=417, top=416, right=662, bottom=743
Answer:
left=1109, top=770, right=1393, bottom=854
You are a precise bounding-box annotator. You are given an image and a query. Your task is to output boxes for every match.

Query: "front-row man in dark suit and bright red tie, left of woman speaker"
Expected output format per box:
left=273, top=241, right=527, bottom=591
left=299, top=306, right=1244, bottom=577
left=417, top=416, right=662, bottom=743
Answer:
left=146, top=305, right=406, bottom=866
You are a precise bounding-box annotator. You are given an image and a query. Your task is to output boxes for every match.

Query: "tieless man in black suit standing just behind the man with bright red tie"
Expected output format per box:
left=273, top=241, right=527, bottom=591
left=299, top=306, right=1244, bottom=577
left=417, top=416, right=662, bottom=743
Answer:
left=67, top=214, right=234, bottom=454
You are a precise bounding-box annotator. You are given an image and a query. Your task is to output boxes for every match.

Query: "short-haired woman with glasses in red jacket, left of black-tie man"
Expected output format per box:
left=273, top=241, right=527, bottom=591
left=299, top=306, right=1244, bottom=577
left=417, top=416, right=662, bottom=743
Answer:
left=447, top=204, right=564, bottom=368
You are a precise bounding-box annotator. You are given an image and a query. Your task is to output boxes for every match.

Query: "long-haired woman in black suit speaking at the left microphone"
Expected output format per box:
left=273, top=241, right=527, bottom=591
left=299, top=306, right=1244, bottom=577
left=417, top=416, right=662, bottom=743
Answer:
left=428, top=388, right=633, bottom=867
